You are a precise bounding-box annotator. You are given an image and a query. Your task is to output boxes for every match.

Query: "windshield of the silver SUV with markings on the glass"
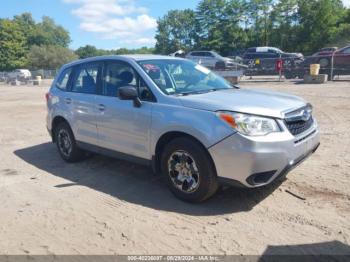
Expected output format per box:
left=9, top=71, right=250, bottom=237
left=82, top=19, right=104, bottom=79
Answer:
left=138, top=59, right=234, bottom=95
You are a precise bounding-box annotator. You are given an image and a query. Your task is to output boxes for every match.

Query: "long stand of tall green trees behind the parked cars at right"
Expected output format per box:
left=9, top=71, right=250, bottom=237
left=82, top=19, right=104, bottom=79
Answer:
left=156, top=0, right=350, bottom=55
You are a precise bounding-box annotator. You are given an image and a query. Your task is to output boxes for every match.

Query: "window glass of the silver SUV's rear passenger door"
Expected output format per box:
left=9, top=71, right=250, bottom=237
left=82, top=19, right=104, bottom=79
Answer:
left=72, top=63, right=102, bottom=94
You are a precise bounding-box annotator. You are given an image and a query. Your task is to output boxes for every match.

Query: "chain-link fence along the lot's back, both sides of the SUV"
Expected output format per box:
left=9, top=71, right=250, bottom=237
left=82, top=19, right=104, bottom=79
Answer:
left=0, top=55, right=350, bottom=83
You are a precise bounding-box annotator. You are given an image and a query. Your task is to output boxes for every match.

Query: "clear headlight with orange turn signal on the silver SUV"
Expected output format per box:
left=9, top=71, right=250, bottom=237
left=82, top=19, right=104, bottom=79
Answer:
left=217, top=111, right=281, bottom=136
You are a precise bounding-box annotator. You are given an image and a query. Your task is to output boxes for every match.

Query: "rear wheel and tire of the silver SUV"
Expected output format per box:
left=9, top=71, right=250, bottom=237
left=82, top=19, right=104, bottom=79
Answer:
left=55, top=122, right=85, bottom=163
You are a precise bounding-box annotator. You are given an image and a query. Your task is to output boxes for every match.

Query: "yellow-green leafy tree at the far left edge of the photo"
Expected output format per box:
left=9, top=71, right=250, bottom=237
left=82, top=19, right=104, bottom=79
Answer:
left=0, top=19, right=27, bottom=71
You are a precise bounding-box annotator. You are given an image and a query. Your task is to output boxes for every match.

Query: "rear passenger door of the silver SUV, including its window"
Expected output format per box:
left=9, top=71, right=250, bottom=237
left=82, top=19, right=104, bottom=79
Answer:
left=65, top=62, right=102, bottom=145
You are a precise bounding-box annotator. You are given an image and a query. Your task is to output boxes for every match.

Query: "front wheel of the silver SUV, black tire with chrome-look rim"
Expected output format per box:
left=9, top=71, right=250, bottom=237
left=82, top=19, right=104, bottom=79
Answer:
left=161, top=137, right=218, bottom=203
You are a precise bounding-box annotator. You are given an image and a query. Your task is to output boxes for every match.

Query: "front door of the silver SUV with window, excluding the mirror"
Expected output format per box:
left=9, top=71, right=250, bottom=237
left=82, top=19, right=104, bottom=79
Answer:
left=96, top=61, right=153, bottom=159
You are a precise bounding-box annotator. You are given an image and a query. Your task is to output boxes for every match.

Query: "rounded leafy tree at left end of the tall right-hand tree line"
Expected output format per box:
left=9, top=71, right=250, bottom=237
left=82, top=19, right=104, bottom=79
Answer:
left=155, top=9, right=197, bottom=54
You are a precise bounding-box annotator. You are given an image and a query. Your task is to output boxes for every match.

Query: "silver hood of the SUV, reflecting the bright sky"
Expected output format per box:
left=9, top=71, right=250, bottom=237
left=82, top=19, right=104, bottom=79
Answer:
left=179, top=89, right=307, bottom=118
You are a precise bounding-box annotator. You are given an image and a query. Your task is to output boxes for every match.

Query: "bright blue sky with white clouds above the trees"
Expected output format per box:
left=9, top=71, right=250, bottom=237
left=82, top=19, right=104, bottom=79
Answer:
left=0, top=0, right=350, bottom=49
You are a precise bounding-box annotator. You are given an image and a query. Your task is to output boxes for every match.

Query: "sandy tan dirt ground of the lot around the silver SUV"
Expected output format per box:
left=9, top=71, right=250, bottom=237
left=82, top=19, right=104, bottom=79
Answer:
left=0, top=79, right=350, bottom=255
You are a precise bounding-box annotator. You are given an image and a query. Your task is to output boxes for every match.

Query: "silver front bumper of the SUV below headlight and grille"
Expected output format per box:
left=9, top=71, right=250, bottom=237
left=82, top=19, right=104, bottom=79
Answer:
left=209, top=122, right=320, bottom=187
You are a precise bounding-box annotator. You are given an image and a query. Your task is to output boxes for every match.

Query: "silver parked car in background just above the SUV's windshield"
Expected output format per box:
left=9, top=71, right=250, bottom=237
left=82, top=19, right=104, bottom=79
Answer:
left=185, top=51, right=237, bottom=69
